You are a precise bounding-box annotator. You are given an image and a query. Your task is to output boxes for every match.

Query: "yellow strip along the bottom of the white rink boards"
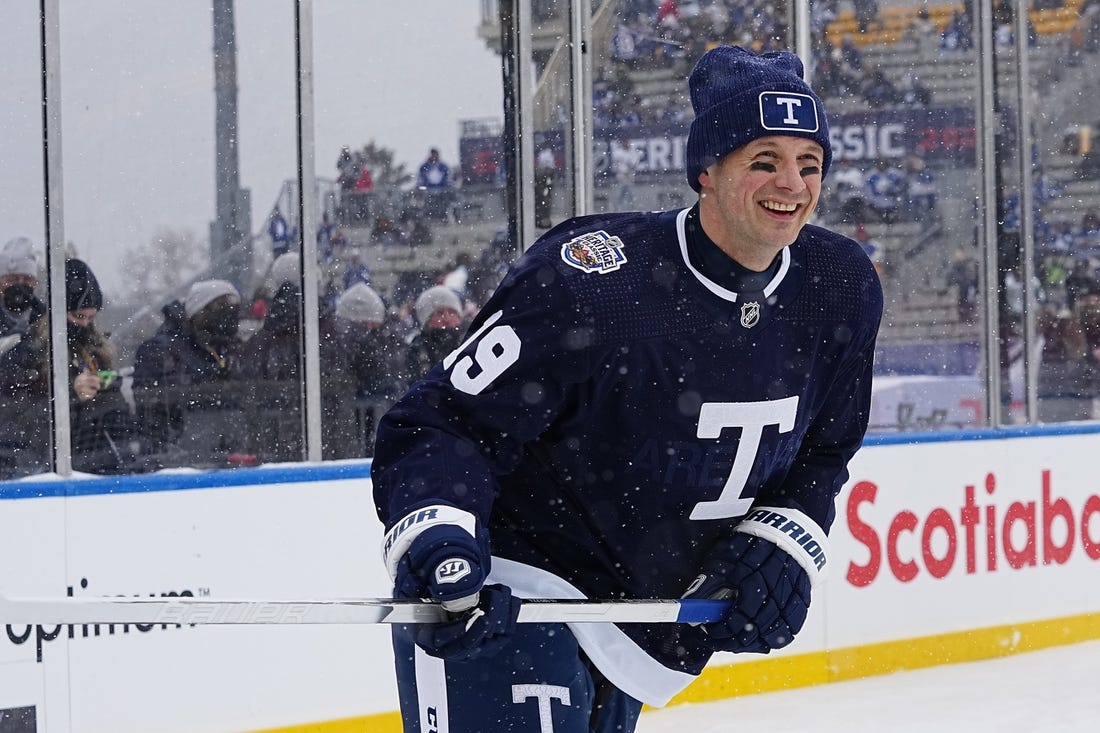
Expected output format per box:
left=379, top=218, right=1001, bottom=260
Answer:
left=247, top=613, right=1100, bottom=733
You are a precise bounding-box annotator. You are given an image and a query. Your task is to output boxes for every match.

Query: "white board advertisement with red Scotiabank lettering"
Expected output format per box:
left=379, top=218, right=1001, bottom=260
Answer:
left=826, top=434, right=1100, bottom=648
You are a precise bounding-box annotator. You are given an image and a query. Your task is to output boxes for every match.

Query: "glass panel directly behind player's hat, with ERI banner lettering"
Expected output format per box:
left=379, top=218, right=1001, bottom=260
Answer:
left=592, top=0, right=791, bottom=211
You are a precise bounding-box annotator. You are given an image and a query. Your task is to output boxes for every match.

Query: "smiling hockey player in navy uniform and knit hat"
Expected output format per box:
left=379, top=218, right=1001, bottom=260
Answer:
left=373, top=46, right=882, bottom=733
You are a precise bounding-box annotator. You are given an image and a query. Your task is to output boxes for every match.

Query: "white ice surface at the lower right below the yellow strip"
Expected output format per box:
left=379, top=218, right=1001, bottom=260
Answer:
left=638, top=642, right=1100, bottom=733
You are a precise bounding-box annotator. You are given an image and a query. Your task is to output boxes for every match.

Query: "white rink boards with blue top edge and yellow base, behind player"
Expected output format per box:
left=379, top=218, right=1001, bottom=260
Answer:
left=0, top=426, right=1100, bottom=733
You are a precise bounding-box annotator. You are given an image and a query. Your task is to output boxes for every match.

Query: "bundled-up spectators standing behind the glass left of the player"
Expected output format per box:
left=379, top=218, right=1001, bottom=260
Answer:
left=0, top=211, right=507, bottom=480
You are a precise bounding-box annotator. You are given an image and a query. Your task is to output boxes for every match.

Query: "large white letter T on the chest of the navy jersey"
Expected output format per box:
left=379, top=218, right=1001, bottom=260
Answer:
left=690, top=395, right=799, bottom=519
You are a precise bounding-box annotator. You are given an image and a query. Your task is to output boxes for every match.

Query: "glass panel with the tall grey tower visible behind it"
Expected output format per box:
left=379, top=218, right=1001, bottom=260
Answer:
left=61, top=0, right=301, bottom=473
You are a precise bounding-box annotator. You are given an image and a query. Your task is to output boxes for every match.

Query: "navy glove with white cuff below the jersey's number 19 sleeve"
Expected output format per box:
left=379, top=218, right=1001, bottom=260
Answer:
left=383, top=505, right=519, bottom=660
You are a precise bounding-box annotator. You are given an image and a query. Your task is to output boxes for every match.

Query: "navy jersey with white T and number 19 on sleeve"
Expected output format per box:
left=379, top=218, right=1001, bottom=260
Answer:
left=372, top=205, right=882, bottom=704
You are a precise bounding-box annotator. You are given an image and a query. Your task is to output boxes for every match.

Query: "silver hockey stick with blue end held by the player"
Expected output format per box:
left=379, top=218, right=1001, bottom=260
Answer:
left=0, top=594, right=729, bottom=626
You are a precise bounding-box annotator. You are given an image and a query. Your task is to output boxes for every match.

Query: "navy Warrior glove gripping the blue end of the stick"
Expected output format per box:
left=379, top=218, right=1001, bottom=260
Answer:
left=684, top=506, right=826, bottom=654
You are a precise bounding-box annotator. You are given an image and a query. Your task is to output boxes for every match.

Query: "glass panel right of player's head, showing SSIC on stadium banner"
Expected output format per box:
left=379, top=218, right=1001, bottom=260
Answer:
left=811, top=1, right=985, bottom=433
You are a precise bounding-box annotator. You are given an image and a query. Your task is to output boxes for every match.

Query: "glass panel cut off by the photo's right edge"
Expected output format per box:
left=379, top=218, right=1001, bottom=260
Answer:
left=1029, top=0, right=1100, bottom=423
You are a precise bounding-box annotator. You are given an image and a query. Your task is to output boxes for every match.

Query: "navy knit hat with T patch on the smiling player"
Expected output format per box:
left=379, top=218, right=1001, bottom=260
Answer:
left=686, top=46, right=833, bottom=192
